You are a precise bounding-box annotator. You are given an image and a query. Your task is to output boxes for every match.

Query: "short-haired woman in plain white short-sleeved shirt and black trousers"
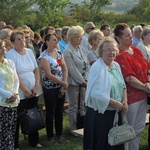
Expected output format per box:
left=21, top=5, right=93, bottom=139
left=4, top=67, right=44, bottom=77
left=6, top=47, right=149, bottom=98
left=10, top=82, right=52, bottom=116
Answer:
left=6, top=31, right=42, bottom=149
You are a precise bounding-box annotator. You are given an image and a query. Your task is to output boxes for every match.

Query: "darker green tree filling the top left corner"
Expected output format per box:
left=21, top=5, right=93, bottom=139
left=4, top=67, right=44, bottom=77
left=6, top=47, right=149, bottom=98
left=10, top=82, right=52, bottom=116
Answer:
left=0, top=0, right=33, bottom=26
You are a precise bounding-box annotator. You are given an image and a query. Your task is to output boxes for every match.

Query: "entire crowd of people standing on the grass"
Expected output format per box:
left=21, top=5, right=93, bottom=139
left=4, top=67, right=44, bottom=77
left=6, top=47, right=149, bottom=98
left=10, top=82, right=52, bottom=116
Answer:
left=0, top=21, right=150, bottom=150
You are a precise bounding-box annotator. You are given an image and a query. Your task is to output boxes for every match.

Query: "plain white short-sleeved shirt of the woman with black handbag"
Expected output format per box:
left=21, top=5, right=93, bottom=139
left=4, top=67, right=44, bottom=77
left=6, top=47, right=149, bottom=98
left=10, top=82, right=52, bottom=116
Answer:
left=6, top=48, right=38, bottom=99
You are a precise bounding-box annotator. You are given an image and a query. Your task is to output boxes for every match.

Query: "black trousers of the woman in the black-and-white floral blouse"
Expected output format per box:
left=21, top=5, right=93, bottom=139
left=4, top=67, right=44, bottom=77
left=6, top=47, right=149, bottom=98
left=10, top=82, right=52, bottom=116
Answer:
left=43, top=88, right=65, bottom=139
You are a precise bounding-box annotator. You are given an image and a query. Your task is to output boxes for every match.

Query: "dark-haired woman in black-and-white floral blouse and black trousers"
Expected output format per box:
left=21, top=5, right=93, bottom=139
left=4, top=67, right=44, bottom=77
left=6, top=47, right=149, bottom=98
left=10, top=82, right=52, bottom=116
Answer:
left=39, top=33, right=68, bottom=143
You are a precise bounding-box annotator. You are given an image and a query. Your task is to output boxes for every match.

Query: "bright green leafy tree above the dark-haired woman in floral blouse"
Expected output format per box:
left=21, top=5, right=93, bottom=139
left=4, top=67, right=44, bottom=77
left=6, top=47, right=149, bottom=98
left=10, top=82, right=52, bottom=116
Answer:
left=35, top=0, right=69, bottom=27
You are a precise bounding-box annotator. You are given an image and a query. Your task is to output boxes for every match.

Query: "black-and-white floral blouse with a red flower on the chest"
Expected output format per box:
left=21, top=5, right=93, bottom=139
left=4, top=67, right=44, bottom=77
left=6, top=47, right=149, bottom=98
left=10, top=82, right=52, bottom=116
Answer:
left=39, top=50, right=63, bottom=89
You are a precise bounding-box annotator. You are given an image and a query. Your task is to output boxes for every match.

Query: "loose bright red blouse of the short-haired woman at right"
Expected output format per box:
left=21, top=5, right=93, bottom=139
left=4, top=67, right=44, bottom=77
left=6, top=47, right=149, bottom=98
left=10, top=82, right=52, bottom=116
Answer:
left=116, top=46, right=150, bottom=104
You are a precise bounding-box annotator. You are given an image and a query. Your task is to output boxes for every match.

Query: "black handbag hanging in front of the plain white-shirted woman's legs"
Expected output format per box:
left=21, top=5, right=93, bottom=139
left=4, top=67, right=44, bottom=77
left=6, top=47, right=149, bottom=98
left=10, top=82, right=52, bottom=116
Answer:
left=19, top=102, right=45, bottom=134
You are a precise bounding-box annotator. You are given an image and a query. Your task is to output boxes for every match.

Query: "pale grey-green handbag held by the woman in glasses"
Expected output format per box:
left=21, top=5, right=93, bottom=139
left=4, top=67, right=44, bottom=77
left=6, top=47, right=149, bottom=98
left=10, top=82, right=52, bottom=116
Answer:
left=108, top=112, right=136, bottom=146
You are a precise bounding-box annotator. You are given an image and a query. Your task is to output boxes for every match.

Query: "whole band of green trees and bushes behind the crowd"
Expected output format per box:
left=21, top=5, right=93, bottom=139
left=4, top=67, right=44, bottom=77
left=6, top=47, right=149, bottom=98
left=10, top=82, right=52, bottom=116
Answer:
left=0, top=0, right=150, bottom=30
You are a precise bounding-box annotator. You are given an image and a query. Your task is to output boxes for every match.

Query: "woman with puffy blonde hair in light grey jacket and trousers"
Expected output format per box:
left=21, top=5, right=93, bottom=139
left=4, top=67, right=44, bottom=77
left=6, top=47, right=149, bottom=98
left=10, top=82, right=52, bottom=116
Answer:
left=64, top=26, right=89, bottom=131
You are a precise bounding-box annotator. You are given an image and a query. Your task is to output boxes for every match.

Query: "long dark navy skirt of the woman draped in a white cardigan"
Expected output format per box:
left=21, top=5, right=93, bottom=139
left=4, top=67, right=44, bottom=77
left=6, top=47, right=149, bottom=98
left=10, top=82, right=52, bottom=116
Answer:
left=83, top=107, right=124, bottom=150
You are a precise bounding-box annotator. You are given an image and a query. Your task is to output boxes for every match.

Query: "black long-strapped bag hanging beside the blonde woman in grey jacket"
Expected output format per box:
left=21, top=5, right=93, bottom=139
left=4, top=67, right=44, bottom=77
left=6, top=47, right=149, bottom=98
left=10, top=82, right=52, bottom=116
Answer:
left=76, top=86, right=84, bottom=129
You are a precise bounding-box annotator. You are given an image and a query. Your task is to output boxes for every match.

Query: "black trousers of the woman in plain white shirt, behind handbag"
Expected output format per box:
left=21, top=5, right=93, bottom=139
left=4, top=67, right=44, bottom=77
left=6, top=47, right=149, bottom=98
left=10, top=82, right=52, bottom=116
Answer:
left=15, top=97, right=39, bottom=148
